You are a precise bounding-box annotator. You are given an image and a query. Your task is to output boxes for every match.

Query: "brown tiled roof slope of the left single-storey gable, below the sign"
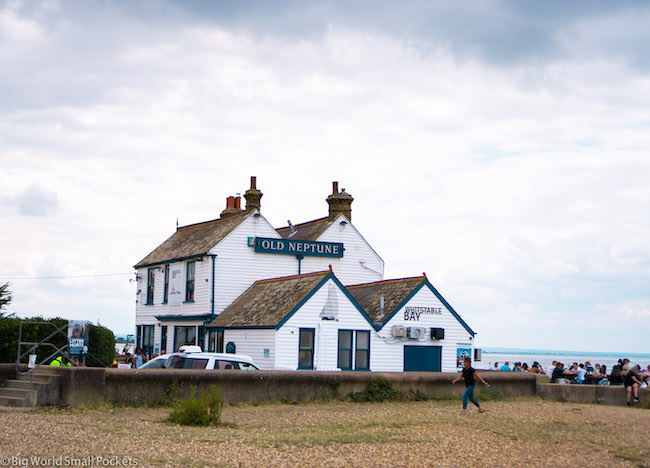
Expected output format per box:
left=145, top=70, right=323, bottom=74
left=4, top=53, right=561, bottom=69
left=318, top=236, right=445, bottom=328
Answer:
left=208, top=271, right=330, bottom=327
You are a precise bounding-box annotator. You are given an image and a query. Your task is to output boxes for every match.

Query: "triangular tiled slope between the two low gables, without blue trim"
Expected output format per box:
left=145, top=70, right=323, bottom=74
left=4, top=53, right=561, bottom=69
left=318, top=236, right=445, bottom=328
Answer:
left=345, top=276, right=426, bottom=322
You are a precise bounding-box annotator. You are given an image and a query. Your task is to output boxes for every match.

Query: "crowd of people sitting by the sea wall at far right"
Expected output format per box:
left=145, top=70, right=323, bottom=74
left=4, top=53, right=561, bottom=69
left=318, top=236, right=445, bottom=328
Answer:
left=493, top=359, right=650, bottom=406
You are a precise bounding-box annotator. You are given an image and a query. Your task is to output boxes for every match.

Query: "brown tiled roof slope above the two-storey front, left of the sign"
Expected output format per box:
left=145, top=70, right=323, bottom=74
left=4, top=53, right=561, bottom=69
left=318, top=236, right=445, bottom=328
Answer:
left=134, top=212, right=252, bottom=268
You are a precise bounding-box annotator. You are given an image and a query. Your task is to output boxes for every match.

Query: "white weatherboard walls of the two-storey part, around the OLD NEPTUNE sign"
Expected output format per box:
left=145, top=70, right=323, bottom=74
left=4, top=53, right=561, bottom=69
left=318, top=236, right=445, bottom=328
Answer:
left=136, top=211, right=384, bottom=325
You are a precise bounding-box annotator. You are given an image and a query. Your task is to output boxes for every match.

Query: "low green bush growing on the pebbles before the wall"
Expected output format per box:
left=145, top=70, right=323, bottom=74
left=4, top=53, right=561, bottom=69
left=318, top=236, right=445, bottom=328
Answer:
left=167, top=385, right=223, bottom=426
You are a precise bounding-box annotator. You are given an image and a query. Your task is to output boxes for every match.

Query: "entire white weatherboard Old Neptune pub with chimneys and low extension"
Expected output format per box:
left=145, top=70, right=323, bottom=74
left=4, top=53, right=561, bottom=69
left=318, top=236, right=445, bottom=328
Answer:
left=135, top=177, right=474, bottom=371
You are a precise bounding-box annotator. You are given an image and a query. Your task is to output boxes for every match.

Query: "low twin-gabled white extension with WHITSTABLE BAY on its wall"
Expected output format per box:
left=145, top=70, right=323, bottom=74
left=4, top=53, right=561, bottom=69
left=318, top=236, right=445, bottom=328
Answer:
left=207, top=271, right=474, bottom=372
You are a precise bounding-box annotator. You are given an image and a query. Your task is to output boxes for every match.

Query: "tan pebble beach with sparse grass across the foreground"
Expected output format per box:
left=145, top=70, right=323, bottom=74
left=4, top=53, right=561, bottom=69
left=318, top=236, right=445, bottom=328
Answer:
left=0, top=399, right=650, bottom=468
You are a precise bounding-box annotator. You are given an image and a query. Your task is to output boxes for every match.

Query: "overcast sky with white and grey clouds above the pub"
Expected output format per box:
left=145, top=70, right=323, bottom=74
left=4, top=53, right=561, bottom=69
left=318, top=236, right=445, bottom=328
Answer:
left=0, top=0, right=650, bottom=353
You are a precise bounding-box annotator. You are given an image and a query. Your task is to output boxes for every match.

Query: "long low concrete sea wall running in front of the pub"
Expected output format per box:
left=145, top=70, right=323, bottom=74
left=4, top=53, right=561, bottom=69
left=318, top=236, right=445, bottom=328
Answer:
left=0, top=364, right=650, bottom=406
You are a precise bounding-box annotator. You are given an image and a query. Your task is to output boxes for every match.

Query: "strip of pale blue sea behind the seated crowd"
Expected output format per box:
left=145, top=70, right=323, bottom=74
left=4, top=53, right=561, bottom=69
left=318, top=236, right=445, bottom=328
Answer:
left=473, top=348, right=650, bottom=373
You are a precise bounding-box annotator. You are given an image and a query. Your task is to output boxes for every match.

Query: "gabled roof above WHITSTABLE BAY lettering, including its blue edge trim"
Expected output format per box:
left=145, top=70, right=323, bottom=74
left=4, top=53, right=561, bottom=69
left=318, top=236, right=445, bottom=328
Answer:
left=346, top=276, right=476, bottom=336
